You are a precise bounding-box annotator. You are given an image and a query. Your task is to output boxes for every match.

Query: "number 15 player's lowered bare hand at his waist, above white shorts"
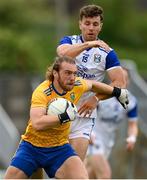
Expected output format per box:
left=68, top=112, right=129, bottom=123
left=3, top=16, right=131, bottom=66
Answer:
left=78, top=96, right=98, bottom=117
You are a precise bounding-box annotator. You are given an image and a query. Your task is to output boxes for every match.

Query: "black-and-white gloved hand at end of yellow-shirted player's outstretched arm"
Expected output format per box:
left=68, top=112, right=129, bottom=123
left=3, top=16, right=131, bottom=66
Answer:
left=112, top=87, right=129, bottom=109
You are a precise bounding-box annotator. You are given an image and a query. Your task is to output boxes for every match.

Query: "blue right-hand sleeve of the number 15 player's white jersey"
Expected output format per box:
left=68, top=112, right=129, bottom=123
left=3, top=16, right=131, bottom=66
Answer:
left=105, top=50, right=120, bottom=70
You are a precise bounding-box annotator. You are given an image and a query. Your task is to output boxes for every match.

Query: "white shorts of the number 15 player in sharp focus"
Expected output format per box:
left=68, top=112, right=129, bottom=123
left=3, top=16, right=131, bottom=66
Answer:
left=69, top=117, right=95, bottom=140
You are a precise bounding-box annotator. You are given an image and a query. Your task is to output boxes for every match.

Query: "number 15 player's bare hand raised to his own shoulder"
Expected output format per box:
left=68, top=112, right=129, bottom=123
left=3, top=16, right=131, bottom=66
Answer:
left=88, top=40, right=111, bottom=51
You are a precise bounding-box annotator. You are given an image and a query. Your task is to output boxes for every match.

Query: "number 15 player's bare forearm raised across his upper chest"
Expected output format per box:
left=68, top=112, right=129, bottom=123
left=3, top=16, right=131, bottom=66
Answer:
left=57, top=42, right=89, bottom=58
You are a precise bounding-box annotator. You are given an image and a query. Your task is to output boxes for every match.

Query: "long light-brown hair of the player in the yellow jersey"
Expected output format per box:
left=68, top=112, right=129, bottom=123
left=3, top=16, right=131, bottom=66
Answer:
left=46, top=56, right=76, bottom=81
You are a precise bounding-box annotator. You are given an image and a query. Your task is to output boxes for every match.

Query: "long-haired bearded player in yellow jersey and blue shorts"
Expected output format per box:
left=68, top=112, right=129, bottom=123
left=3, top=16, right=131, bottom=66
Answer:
left=5, top=57, right=128, bottom=179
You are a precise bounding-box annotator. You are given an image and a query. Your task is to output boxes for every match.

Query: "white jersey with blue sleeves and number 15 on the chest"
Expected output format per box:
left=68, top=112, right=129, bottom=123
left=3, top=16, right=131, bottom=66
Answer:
left=60, top=35, right=120, bottom=118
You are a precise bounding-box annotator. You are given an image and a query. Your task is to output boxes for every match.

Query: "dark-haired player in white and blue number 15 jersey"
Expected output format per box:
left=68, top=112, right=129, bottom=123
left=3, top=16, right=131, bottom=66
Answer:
left=57, top=5, right=125, bottom=160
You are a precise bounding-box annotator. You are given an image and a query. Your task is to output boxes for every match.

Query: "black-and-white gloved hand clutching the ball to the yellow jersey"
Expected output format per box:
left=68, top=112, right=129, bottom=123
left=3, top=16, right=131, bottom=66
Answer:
left=58, top=101, right=77, bottom=124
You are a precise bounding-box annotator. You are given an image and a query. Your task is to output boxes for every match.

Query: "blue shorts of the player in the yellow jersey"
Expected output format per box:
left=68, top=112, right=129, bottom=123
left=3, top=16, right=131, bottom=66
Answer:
left=10, top=141, right=77, bottom=178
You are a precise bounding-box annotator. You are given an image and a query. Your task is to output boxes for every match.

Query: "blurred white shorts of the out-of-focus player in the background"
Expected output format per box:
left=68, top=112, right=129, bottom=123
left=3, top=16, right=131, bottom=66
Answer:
left=87, top=133, right=114, bottom=158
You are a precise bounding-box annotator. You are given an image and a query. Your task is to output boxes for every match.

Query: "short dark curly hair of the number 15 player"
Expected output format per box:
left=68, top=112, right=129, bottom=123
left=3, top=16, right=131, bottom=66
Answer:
left=79, top=4, right=104, bottom=21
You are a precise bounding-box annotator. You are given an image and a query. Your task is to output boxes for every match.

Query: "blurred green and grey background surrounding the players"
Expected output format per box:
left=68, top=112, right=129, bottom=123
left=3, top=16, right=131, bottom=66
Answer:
left=0, top=0, right=147, bottom=179
